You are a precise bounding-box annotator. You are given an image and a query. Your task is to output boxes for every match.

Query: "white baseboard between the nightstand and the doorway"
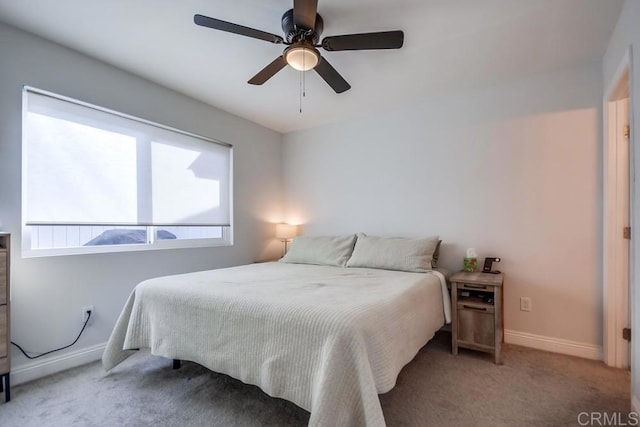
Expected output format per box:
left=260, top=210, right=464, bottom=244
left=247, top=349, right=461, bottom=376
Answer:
left=504, top=329, right=602, bottom=360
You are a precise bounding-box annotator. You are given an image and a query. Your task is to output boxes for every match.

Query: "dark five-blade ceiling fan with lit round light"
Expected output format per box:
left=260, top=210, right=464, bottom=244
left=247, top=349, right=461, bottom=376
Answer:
left=193, top=0, right=404, bottom=93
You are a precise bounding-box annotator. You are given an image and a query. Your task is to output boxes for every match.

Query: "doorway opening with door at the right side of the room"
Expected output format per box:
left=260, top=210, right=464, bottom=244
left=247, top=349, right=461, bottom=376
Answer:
left=603, top=61, right=634, bottom=368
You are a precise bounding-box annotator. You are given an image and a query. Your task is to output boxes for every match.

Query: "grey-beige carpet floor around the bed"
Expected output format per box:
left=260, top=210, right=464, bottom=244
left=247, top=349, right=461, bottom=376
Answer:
left=0, top=332, right=630, bottom=427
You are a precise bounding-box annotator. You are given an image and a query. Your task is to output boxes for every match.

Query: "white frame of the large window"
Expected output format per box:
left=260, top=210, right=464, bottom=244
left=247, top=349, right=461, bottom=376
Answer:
left=21, top=86, right=234, bottom=258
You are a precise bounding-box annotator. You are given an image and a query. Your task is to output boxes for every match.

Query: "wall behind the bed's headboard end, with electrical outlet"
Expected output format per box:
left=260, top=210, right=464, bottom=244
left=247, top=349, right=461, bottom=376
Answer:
left=283, top=63, right=602, bottom=358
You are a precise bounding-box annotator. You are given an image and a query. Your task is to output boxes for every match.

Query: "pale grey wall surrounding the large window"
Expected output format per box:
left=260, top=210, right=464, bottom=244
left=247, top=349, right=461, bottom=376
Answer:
left=0, top=24, right=282, bottom=382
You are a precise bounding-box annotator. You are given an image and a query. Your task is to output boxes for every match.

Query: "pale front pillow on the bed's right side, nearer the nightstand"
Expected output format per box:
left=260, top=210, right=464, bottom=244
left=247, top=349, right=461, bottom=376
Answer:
left=347, top=234, right=439, bottom=273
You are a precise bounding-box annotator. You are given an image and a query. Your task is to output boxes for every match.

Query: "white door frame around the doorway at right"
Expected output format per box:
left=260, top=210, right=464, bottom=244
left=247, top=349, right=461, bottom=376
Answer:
left=602, top=47, right=638, bottom=368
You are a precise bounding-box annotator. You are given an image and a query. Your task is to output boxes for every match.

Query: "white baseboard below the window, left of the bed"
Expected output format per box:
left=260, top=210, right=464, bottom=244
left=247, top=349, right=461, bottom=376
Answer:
left=11, top=343, right=107, bottom=385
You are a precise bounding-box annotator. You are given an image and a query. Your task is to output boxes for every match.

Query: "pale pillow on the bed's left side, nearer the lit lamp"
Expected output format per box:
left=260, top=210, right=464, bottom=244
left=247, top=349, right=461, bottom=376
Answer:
left=280, top=234, right=356, bottom=267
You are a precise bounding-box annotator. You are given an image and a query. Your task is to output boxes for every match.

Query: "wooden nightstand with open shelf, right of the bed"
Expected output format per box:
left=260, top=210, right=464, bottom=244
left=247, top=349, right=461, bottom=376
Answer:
left=449, top=271, right=504, bottom=365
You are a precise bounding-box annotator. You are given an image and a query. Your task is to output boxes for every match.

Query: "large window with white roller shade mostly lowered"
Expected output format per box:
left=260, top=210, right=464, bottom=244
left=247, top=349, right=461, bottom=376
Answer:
left=22, top=87, right=232, bottom=256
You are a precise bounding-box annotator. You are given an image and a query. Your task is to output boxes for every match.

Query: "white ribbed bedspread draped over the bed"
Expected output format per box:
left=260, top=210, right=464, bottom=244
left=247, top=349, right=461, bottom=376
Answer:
left=102, top=263, right=449, bottom=426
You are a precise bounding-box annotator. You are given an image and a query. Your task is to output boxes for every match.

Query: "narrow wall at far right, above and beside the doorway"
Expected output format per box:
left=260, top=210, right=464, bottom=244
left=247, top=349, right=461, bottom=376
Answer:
left=603, top=0, right=640, bottom=411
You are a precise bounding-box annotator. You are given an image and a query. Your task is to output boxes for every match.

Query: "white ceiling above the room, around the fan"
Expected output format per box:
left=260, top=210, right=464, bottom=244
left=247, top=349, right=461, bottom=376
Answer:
left=0, top=0, right=624, bottom=133
